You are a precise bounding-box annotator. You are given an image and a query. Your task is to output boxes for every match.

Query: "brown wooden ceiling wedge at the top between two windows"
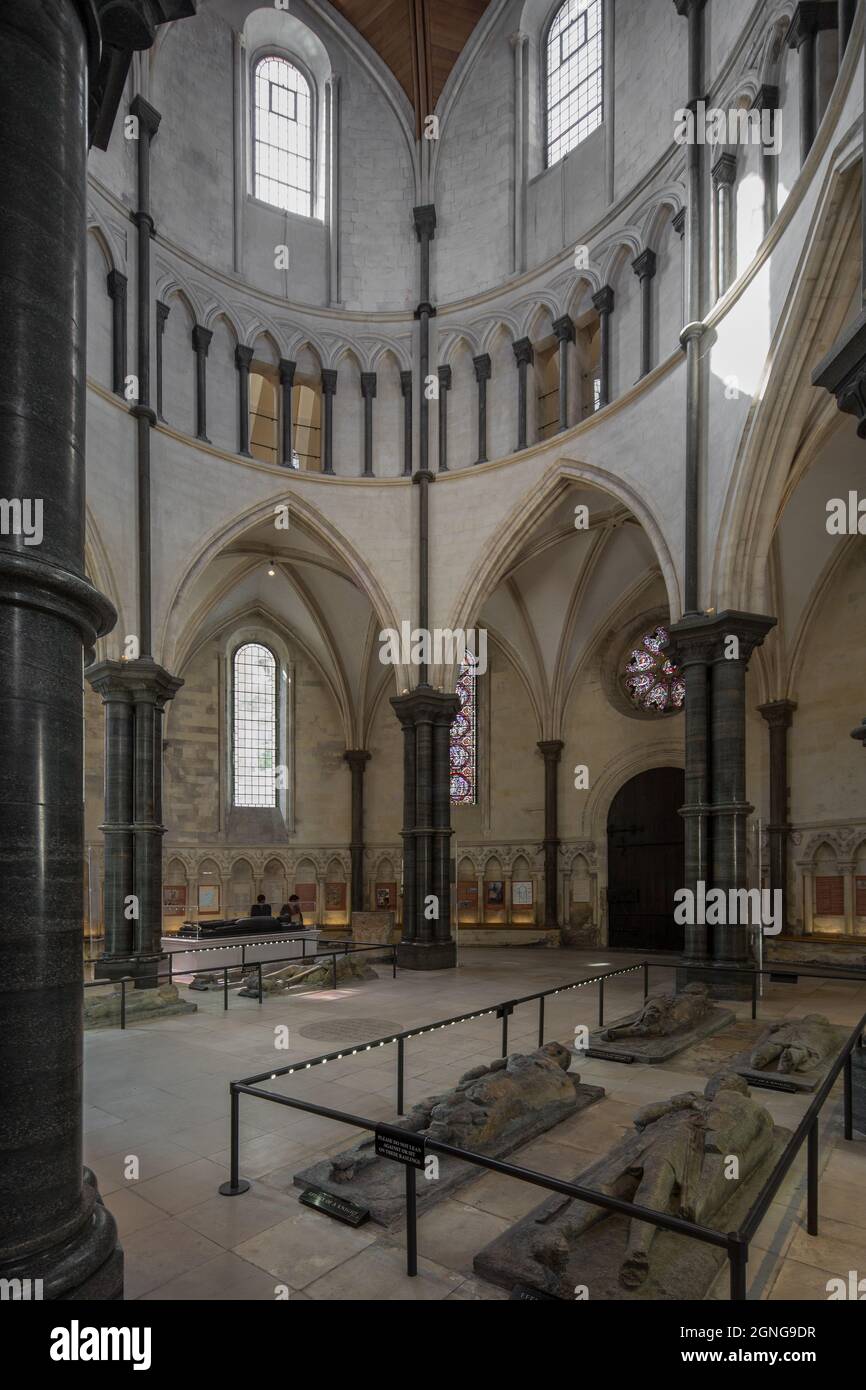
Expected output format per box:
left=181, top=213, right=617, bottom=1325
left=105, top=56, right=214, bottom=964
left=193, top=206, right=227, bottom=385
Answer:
left=326, top=0, right=489, bottom=133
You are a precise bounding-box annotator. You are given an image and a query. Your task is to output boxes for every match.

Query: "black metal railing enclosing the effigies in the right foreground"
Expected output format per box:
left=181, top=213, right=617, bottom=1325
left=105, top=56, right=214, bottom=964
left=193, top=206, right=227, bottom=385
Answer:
left=218, top=960, right=866, bottom=1302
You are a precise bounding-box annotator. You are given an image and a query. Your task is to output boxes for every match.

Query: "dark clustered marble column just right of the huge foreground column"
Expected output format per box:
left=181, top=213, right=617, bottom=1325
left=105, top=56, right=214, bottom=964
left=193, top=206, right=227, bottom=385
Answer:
left=86, top=657, right=183, bottom=990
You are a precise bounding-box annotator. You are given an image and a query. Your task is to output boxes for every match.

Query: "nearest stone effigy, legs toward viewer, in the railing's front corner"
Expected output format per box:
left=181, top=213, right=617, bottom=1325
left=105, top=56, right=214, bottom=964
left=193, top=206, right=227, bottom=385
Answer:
left=531, top=1073, right=773, bottom=1289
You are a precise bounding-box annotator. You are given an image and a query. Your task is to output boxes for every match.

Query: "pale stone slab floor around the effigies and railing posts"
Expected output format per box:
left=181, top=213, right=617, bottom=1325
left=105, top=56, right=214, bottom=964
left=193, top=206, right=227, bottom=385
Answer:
left=85, top=948, right=866, bottom=1301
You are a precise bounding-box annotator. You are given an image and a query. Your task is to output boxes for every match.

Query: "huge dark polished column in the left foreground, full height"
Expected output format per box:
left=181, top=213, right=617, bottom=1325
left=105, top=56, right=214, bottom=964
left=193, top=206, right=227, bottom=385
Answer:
left=0, top=0, right=195, bottom=1301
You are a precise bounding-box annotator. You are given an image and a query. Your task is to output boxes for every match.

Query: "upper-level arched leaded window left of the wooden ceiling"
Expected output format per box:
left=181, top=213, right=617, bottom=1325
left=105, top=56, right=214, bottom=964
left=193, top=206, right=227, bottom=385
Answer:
left=253, top=54, right=313, bottom=217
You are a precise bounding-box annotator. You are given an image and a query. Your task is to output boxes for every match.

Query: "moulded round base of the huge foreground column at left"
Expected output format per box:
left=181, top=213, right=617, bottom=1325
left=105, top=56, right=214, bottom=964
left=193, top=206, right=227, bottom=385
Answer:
left=0, top=1169, right=124, bottom=1302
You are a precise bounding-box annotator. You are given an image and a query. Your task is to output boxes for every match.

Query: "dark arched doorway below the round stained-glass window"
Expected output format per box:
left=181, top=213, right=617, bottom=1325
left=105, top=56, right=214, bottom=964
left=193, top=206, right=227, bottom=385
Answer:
left=607, top=767, right=685, bottom=951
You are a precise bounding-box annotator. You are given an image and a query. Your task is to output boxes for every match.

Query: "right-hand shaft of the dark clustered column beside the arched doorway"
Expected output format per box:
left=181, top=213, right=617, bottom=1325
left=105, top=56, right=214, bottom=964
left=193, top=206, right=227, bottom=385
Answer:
left=710, top=613, right=776, bottom=992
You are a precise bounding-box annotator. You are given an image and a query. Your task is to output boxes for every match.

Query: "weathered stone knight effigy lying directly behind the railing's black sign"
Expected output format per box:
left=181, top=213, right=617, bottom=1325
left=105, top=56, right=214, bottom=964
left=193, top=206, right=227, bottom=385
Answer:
left=331, top=1043, right=580, bottom=1183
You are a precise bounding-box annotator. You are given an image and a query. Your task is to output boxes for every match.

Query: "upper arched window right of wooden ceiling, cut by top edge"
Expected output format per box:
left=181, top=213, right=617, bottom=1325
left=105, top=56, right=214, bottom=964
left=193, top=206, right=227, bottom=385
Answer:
left=546, top=0, right=603, bottom=165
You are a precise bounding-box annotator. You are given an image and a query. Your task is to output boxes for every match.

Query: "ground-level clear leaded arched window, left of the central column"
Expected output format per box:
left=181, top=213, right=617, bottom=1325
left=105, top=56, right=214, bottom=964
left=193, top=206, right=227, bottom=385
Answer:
left=232, top=642, right=277, bottom=806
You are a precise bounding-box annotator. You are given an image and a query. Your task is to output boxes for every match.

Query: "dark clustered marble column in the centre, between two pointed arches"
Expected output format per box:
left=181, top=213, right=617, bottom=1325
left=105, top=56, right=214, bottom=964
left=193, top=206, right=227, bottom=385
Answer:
left=391, top=685, right=460, bottom=970
